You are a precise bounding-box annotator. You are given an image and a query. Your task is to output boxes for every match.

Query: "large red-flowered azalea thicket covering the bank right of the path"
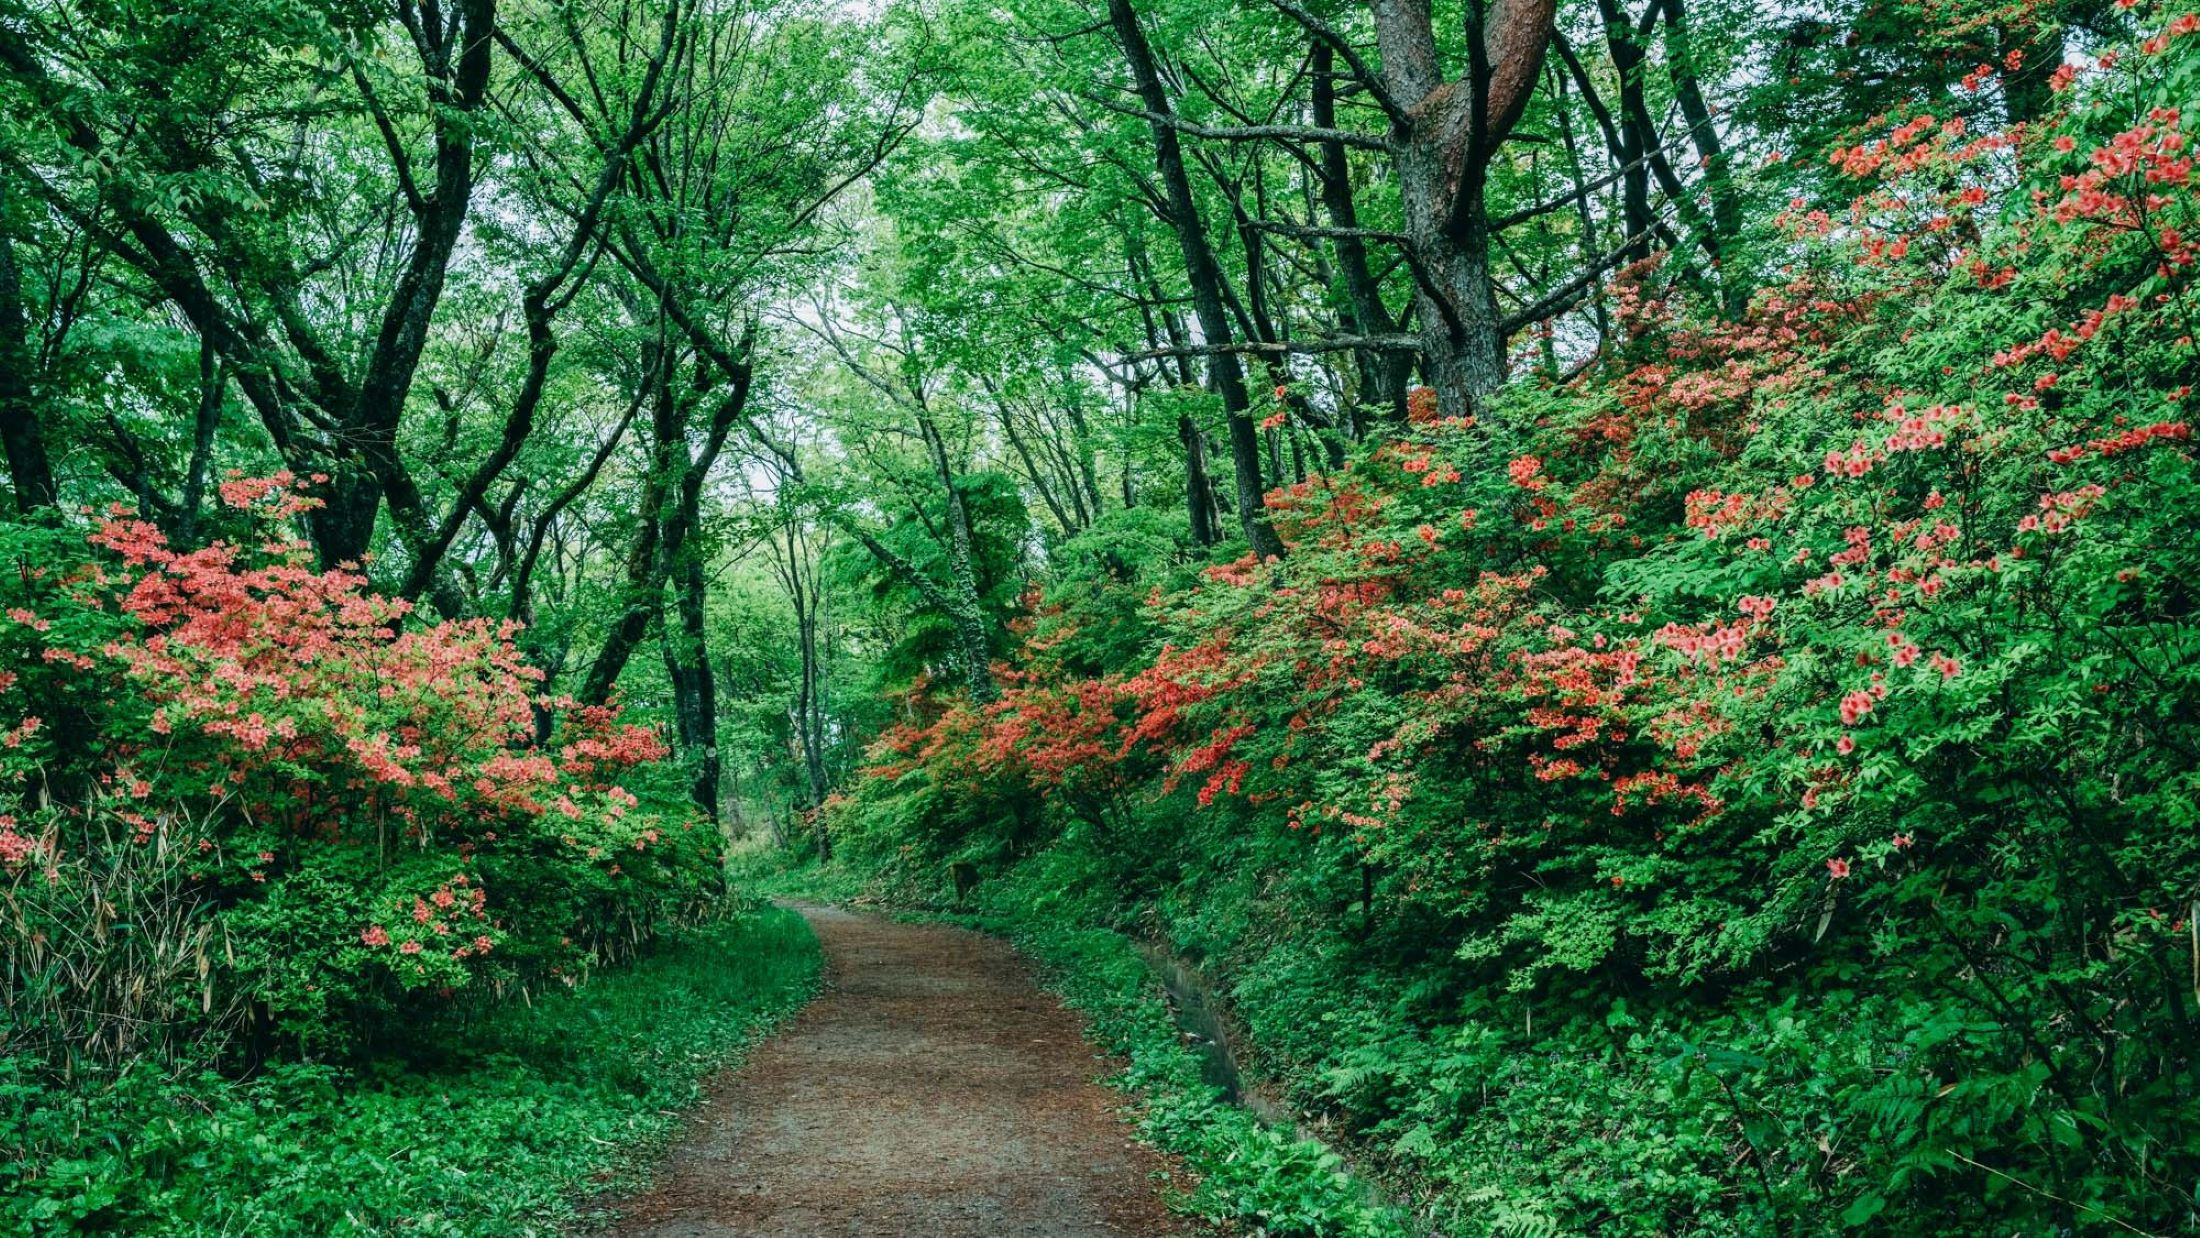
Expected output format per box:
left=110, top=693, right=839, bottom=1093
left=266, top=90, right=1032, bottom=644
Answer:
left=862, top=15, right=2200, bottom=1234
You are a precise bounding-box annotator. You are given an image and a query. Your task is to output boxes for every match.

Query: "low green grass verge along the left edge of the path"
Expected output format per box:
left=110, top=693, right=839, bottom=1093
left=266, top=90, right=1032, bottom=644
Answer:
left=0, top=908, right=821, bottom=1236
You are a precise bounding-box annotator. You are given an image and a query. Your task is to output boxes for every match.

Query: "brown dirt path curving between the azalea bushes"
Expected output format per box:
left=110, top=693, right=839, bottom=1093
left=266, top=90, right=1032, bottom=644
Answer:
left=616, top=908, right=1190, bottom=1238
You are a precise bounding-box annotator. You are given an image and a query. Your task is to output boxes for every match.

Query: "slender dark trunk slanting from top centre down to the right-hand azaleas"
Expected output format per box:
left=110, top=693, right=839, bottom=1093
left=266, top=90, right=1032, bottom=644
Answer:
left=1109, top=0, right=1285, bottom=559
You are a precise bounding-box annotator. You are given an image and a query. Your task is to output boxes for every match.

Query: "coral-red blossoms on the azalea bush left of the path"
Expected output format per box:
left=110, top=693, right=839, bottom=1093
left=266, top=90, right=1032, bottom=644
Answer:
left=0, top=475, right=708, bottom=1015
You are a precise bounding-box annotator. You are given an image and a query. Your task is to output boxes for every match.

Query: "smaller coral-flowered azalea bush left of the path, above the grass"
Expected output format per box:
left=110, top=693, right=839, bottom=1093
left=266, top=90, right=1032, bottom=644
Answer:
left=0, top=475, right=719, bottom=1060
